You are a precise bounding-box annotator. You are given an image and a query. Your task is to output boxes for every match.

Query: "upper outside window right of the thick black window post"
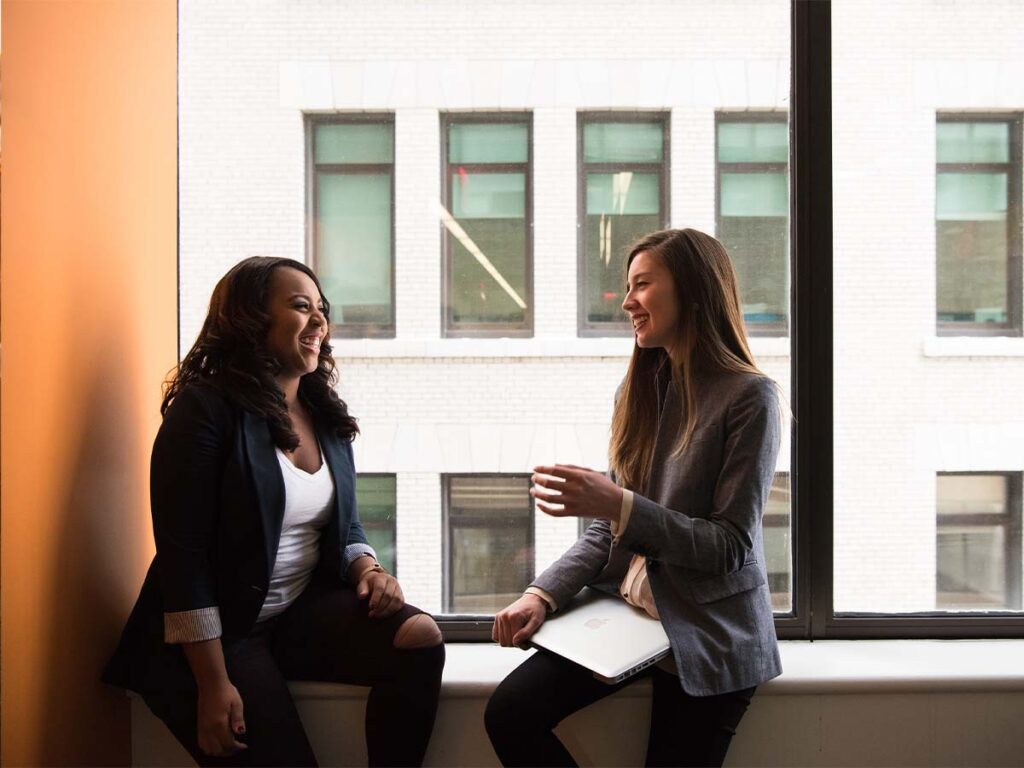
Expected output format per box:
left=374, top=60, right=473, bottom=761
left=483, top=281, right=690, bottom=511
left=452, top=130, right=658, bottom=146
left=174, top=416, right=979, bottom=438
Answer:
left=935, top=117, right=1020, bottom=330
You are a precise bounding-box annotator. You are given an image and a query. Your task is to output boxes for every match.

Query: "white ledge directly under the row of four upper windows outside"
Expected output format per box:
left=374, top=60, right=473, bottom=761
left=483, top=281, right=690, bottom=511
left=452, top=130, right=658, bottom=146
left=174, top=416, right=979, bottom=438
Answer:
left=331, top=336, right=790, bottom=359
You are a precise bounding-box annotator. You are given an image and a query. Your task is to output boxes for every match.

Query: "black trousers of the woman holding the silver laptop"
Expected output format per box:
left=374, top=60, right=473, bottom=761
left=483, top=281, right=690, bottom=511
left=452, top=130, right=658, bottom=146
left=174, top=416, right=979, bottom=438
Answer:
left=484, top=651, right=756, bottom=766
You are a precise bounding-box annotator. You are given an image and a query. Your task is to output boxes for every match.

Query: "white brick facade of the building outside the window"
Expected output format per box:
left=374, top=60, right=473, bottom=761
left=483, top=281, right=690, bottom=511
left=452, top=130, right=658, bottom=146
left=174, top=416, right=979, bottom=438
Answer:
left=179, top=0, right=1024, bottom=610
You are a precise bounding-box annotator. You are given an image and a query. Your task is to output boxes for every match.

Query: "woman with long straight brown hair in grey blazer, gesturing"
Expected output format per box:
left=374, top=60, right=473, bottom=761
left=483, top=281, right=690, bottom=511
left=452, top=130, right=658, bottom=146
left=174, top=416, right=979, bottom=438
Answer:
left=485, top=229, right=781, bottom=766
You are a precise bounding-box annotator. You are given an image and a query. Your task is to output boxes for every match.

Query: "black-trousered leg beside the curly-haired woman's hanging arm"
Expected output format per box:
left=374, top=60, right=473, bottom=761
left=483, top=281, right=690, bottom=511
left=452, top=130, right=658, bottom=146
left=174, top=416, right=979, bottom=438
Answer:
left=145, top=626, right=316, bottom=766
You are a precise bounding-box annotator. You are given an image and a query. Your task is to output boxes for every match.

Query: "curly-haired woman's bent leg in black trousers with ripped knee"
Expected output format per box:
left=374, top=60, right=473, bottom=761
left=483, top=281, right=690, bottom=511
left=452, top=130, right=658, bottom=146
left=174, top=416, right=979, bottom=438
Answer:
left=274, top=583, right=444, bottom=766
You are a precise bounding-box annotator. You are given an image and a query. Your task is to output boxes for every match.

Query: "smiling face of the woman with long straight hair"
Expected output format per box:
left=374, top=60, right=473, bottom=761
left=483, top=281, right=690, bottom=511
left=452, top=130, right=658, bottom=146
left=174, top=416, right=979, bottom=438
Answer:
left=623, top=251, right=679, bottom=354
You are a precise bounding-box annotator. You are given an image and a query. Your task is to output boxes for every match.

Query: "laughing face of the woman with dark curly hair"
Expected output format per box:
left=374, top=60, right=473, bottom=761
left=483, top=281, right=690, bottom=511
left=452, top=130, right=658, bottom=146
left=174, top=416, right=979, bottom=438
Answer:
left=266, top=267, right=328, bottom=391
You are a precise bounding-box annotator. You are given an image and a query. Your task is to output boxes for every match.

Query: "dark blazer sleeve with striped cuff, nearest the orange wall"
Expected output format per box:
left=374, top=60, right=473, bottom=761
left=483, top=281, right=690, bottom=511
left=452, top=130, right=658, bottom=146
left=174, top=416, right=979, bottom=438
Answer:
left=150, top=387, right=230, bottom=643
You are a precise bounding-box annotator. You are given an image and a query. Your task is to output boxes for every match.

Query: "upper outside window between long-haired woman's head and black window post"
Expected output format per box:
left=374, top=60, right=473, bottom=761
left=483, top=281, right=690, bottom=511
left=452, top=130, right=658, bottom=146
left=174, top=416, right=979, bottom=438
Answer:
left=717, top=113, right=790, bottom=335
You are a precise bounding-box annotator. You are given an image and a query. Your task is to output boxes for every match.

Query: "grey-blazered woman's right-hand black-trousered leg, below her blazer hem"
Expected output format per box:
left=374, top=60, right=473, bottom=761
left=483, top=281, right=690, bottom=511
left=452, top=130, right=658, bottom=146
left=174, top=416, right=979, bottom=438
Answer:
left=646, top=670, right=757, bottom=768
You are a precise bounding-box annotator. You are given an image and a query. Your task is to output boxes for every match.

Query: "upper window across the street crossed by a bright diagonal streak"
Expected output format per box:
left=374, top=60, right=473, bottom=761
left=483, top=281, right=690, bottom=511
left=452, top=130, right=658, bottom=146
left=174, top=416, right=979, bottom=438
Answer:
left=442, top=122, right=530, bottom=333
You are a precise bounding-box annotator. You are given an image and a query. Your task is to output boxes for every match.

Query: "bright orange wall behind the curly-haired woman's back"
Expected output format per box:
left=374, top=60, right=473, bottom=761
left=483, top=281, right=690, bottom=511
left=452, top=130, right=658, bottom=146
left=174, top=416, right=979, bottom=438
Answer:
left=0, top=0, right=177, bottom=765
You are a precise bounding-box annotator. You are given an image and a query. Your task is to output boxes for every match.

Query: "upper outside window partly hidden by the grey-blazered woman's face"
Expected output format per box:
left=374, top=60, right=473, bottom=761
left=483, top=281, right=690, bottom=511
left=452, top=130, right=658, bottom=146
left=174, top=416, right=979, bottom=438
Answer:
left=581, top=118, right=668, bottom=330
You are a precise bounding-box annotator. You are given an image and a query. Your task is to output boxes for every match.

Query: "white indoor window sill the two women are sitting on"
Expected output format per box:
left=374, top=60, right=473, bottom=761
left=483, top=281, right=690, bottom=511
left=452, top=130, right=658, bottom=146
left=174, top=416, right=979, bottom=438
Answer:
left=282, top=640, right=1024, bottom=698
